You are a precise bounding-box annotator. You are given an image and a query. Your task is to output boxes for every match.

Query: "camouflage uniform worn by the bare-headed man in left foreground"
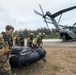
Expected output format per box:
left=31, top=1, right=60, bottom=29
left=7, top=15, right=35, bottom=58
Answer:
left=0, top=34, right=11, bottom=75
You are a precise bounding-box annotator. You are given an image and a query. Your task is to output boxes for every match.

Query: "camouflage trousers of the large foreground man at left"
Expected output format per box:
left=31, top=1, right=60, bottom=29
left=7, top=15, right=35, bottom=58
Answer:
left=0, top=55, right=12, bottom=75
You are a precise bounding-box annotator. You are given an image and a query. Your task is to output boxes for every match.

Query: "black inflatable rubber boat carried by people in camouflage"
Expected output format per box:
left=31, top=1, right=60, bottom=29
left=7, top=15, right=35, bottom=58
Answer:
left=10, top=46, right=46, bottom=67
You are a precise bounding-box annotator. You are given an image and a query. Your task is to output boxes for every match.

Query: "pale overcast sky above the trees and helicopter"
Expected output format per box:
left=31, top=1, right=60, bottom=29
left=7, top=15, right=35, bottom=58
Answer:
left=0, top=0, right=76, bottom=32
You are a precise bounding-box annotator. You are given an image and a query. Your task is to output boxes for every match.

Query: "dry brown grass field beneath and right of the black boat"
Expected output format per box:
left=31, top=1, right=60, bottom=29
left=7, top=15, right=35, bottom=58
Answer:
left=12, top=46, right=76, bottom=75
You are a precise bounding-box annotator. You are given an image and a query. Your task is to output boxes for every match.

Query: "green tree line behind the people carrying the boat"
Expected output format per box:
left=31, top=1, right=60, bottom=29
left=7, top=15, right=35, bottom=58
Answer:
left=14, top=27, right=59, bottom=39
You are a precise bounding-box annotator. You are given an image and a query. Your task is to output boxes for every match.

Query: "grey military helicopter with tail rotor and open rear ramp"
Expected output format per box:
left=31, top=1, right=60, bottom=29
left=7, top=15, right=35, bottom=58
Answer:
left=34, top=5, right=76, bottom=41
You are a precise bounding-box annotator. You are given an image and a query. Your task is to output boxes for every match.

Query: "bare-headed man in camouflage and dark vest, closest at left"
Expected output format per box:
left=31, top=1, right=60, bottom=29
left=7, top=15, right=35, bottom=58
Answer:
left=0, top=25, right=14, bottom=75
